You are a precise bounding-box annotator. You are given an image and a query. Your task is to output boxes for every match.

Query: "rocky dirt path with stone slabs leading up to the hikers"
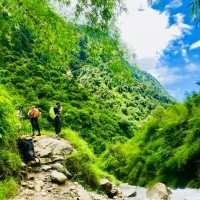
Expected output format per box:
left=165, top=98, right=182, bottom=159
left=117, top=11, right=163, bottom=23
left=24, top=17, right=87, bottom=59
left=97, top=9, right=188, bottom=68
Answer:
left=12, top=136, right=117, bottom=200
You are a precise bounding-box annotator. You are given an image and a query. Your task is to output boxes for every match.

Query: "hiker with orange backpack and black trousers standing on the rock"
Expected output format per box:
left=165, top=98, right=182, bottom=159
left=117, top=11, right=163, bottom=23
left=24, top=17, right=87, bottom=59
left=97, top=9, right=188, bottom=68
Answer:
left=28, top=106, right=41, bottom=136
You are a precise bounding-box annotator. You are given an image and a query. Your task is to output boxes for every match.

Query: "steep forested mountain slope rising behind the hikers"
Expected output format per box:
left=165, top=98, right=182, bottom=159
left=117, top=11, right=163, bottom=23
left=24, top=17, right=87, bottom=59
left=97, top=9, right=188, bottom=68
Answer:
left=0, top=0, right=172, bottom=153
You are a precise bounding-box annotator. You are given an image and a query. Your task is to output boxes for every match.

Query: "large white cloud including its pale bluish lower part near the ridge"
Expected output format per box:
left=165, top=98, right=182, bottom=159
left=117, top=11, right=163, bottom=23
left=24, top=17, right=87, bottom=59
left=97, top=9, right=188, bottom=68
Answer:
left=119, top=0, right=192, bottom=85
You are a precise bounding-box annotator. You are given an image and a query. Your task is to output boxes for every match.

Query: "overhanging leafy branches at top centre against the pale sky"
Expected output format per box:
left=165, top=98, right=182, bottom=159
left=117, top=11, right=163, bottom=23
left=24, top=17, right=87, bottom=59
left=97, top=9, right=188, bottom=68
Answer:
left=43, top=0, right=127, bottom=31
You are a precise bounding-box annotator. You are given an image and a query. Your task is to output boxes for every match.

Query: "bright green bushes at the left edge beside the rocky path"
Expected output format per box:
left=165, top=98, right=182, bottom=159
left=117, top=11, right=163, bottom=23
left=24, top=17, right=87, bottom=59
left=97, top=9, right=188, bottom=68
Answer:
left=0, top=85, right=21, bottom=200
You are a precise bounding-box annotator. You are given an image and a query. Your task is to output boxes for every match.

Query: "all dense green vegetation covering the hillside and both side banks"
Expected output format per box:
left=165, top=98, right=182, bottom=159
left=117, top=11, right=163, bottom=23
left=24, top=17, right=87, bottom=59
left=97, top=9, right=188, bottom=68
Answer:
left=0, top=0, right=200, bottom=199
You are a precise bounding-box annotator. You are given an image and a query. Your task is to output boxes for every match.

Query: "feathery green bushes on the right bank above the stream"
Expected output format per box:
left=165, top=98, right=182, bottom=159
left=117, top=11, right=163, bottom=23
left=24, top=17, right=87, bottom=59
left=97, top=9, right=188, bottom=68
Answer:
left=101, top=93, right=200, bottom=188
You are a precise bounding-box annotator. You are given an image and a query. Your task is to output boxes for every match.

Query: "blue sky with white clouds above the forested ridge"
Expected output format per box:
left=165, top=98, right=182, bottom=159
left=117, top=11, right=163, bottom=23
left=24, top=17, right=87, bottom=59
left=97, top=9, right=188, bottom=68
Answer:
left=118, top=0, right=200, bottom=102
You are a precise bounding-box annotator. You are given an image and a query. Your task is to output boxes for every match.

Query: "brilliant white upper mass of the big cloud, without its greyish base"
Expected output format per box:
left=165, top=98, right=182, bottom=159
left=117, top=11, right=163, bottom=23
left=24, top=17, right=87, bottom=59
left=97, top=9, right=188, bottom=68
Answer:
left=119, top=0, right=190, bottom=58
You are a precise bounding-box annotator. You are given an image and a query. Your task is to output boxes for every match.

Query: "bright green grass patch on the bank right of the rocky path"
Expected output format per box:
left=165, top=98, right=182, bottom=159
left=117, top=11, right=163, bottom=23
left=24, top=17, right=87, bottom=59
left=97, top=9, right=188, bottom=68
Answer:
left=61, top=129, right=118, bottom=189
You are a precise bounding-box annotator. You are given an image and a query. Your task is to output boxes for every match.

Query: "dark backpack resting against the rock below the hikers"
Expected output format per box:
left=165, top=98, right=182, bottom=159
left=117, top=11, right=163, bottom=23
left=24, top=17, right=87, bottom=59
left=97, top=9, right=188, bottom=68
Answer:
left=18, top=138, right=37, bottom=163
